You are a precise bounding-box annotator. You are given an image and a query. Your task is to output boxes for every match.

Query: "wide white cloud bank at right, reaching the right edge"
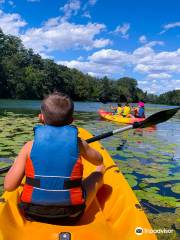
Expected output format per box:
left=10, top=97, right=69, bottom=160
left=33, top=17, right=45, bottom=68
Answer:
left=58, top=46, right=180, bottom=79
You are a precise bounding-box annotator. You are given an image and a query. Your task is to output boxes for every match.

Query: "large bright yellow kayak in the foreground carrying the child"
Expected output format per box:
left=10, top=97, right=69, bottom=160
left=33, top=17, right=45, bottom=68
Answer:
left=0, top=129, right=157, bottom=240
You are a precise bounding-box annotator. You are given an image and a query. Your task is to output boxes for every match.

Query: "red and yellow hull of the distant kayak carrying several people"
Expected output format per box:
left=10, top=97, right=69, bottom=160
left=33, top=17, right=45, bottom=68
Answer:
left=98, top=109, right=145, bottom=124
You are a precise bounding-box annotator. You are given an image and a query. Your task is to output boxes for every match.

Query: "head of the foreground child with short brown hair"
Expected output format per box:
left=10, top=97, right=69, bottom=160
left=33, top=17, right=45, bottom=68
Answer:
left=41, top=92, right=74, bottom=126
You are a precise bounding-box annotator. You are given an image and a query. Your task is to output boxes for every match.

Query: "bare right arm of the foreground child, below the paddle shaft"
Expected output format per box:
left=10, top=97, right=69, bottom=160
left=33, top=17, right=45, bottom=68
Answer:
left=79, top=139, right=103, bottom=166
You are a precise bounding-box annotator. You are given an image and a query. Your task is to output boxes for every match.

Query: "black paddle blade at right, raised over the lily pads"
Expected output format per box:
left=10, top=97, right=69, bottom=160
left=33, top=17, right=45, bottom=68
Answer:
left=133, top=107, right=180, bottom=128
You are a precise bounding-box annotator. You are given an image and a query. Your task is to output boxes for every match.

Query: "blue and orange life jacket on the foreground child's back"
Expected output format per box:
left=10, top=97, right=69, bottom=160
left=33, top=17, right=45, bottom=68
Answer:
left=21, top=125, right=84, bottom=206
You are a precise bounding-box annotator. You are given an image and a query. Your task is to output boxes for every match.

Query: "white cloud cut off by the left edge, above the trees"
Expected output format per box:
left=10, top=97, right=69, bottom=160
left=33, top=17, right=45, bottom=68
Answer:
left=0, top=10, right=27, bottom=35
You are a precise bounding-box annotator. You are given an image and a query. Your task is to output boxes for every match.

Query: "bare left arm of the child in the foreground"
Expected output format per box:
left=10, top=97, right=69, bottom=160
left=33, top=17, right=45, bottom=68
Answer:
left=4, top=141, right=32, bottom=191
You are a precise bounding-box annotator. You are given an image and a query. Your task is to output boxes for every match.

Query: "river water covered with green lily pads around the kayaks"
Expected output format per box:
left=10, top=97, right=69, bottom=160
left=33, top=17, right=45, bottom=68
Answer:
left=0, top=100, right=180, bottom=240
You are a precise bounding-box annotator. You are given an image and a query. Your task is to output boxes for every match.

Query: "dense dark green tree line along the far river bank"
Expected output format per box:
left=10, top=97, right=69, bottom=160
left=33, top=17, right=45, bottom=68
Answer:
left=0, top=30, right=180, bottom=105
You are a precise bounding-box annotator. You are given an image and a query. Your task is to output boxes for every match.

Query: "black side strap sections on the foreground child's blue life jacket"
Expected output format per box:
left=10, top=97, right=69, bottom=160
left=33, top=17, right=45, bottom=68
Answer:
left=26, top=177, right=82, bottom=189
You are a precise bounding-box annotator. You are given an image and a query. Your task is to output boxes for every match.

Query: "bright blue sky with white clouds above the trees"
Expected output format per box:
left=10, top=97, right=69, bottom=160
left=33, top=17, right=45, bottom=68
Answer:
left=0, top=0, right=180, bottom=94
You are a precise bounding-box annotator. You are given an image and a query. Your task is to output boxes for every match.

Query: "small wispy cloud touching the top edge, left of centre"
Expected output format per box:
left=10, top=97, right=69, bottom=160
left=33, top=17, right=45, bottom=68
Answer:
left=60, top=0, right=81, bottom=21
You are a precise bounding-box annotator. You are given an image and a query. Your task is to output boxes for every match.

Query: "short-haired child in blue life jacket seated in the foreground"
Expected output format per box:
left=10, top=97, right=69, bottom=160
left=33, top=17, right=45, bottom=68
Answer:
left=4, top=93, right=104, bottom=223
